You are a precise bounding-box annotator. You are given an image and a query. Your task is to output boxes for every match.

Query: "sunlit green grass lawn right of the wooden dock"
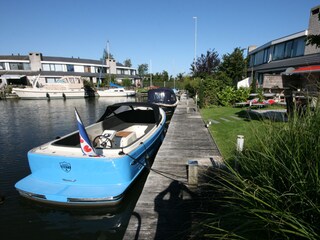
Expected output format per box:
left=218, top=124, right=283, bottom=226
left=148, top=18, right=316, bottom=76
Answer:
left=201, top=107, right=285, bottom=159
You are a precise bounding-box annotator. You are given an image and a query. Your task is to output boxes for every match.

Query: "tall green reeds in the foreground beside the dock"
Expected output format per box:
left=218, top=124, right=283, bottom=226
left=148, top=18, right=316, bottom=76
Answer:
left=197, top=108, right=320, bottom=239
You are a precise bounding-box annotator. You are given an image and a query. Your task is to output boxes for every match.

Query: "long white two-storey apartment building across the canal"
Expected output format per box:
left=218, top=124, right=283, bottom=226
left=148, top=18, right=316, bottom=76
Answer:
left=0, top=52, right=139, bottom=85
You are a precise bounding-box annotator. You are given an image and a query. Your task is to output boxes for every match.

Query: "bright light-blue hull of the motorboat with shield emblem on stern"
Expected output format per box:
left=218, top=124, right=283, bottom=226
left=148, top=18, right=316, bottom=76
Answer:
left=15, top=102, right=165, bottom=206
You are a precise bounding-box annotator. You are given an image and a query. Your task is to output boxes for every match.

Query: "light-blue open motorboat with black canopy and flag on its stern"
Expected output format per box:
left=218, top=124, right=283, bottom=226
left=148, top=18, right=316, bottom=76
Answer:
left=15, top=102, right=166, bottom=206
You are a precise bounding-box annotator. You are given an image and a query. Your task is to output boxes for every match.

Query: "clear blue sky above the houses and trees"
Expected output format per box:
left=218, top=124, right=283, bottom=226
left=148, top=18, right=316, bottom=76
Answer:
left=0, top=0, right=320, bottom=76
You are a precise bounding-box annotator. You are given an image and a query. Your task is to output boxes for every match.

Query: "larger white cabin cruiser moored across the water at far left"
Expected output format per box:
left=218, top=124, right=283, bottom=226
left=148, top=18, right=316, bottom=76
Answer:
left=12, top=76, right=85, bottom=99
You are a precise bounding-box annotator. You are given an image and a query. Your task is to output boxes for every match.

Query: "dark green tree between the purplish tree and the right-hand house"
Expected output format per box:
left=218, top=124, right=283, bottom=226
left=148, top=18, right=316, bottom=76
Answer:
left=219, top=47, right=247, bottom=86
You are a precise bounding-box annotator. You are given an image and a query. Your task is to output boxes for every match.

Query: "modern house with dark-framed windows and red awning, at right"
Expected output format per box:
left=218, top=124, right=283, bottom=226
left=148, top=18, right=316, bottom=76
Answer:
left=248, top=5, right=320, bottom=92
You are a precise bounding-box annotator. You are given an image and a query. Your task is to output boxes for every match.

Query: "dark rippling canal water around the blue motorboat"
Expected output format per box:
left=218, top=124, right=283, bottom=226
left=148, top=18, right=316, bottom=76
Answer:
left=0, top=98, right=153, bottom=240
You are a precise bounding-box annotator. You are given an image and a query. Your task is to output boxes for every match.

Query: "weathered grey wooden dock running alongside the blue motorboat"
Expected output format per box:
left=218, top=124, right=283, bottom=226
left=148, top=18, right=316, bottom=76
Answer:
left=123, top=96, right=221, bottom=240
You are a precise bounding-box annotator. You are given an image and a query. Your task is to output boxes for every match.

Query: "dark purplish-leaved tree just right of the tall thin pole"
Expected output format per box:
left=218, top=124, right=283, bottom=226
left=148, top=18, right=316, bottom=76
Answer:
left=190, top=50, right=220, bottom=78
